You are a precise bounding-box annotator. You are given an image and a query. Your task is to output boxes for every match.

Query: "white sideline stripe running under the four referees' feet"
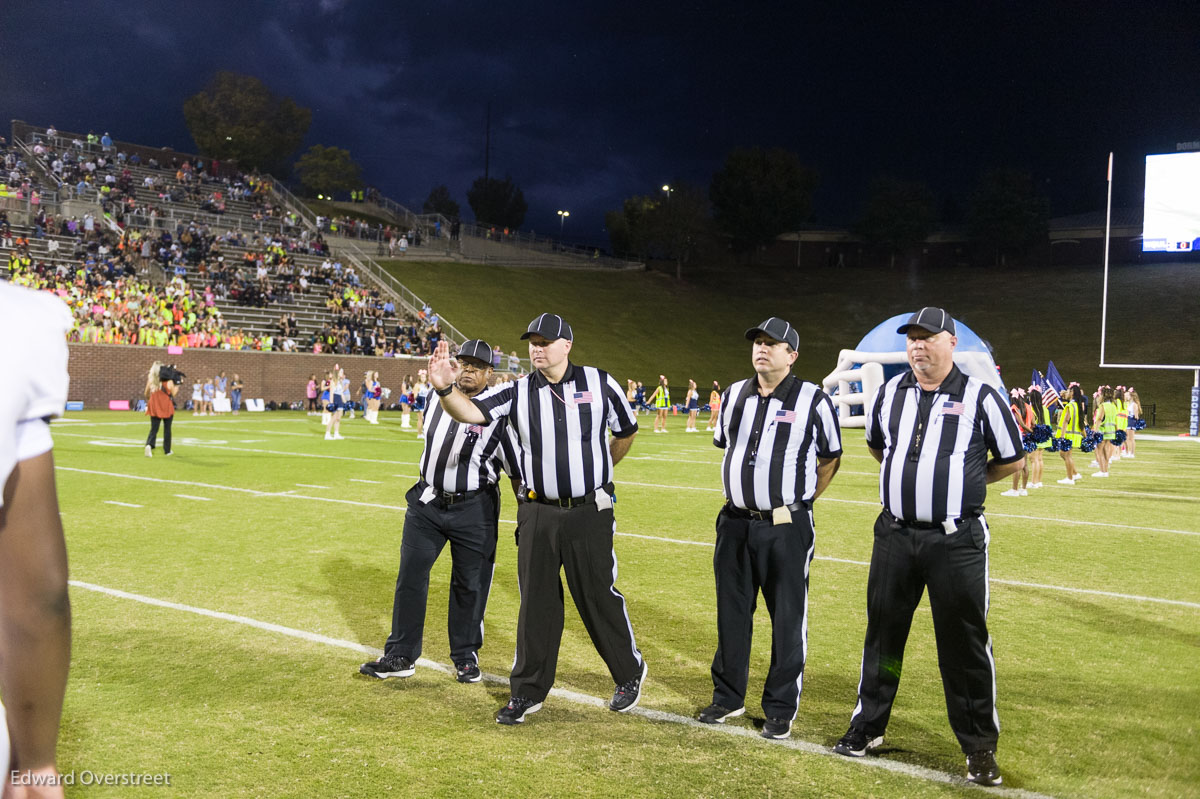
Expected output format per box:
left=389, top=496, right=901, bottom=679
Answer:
left=70, top=579, right=1050, bottom=799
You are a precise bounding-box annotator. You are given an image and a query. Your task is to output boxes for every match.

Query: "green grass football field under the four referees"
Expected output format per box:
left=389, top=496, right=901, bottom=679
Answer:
left=54, top=407, right=1200, bottom=798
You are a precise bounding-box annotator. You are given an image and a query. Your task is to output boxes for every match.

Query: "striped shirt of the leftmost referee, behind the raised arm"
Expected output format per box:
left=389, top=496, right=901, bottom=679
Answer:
left=421, top=395, right=517, bottom=494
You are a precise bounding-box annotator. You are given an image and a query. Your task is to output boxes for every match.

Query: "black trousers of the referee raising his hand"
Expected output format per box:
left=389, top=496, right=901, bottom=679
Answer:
left=509, top=503, right=642, bottom=702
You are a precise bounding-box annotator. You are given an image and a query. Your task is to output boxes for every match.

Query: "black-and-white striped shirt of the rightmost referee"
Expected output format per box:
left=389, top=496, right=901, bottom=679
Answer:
left=866, top=366, right=1025, bottom=522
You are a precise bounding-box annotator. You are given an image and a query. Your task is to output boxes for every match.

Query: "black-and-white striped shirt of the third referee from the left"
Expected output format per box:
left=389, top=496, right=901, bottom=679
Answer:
left=713, top=374, right=841, bottom=511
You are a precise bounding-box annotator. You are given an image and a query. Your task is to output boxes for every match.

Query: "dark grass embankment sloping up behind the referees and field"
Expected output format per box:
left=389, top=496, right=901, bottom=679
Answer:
left=389, top=262, right=1200, bottom=429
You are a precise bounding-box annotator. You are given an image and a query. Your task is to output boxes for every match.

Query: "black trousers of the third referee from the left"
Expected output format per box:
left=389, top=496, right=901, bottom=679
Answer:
left=713, top=509, right=814, bottom=719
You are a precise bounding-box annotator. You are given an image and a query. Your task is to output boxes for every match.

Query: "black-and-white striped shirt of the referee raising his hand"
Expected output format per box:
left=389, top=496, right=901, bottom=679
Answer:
left=472, top=364, right=637, bottom=499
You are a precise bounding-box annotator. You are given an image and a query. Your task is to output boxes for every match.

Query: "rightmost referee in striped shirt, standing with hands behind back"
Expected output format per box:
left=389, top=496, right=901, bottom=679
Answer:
left=834, top=307, right=1025, bottom=786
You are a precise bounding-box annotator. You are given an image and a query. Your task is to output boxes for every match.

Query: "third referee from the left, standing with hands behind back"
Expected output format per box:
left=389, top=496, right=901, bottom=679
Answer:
left=700, top=317, right=841, bottom=738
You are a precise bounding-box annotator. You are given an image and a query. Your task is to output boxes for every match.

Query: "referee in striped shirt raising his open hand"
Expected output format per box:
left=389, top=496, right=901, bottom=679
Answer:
left=430, top=313, right=646, bottom=725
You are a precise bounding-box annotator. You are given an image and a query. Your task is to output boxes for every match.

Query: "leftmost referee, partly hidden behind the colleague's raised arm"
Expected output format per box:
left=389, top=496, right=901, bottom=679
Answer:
left=359, top=338, right=517, bottom=683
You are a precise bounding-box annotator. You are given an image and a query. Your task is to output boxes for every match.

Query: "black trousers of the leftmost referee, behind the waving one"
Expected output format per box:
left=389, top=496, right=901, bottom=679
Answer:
left=384, top=485, right=500, bottom=663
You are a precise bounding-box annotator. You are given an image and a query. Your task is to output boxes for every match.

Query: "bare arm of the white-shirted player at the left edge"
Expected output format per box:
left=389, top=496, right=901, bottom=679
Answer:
left=0, top=452, right=71, bottom=799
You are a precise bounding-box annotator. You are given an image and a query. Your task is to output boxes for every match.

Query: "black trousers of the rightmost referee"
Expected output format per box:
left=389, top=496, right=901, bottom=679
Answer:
left=851, top=512, right=1000, bottom=753
